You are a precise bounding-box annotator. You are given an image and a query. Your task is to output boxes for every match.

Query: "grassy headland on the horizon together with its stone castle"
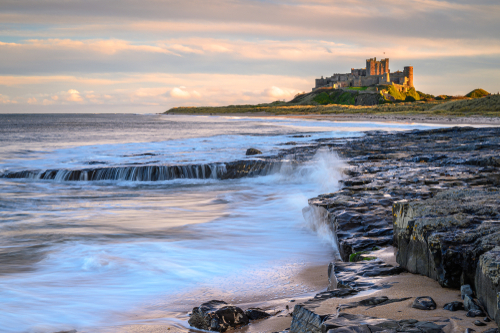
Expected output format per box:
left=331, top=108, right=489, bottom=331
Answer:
left=165, top=58, right=500, bottom=123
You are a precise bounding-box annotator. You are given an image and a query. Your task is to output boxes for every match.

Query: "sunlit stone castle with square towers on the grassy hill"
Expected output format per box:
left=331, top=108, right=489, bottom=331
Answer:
left=313, top=58, right=413, bottom=91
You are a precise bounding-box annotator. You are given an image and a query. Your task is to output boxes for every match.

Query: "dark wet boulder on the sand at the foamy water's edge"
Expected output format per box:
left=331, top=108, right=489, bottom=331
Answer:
left=188, top=300, right=248, bottom=332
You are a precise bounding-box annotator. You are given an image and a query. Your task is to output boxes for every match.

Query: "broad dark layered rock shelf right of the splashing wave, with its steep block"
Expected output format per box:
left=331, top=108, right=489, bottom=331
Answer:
left=309, top=128, right=500, bottom=330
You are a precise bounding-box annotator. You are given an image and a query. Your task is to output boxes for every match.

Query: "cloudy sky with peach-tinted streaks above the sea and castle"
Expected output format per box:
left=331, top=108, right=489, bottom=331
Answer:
left=0, top=0, right=500, bottom=113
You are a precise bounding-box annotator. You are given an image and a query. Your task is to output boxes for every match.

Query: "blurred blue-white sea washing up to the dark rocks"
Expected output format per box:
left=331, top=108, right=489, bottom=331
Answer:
left=0, top=114, right=444, bottom=332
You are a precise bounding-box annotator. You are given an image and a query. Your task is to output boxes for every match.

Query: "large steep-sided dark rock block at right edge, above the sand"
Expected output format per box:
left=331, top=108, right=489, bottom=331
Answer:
left=393, top=189, right=500, bottom=324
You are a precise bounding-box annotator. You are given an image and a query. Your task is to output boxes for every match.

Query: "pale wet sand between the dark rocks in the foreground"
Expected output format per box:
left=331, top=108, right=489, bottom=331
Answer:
left=100, top=247, right=497, bottom=333
